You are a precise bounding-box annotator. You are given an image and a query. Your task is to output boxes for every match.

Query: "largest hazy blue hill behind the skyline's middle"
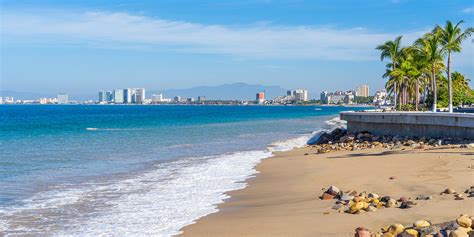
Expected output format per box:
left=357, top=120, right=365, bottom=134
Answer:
left=156, top=82, right=287, bottom=100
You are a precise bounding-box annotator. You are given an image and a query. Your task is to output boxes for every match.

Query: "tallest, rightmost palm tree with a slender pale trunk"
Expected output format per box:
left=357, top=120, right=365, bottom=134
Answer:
left=433, top=21, right=474, bottom=113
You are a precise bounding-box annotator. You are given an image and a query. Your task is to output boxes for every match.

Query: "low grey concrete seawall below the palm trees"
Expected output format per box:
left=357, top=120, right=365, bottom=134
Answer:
left=340, top=112, right=474, bottom=139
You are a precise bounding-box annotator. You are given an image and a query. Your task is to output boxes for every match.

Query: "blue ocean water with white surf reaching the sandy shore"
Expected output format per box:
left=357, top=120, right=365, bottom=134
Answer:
left=0, top=105, right=364, bottom=236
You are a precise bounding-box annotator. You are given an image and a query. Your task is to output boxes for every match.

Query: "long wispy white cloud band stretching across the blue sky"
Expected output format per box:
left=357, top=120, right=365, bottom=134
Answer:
left=1, top=11, right=472, bottom=64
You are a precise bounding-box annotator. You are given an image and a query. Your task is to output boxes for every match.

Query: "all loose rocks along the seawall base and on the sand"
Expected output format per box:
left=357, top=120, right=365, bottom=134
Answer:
left=305, top=128, right=474, bottom=237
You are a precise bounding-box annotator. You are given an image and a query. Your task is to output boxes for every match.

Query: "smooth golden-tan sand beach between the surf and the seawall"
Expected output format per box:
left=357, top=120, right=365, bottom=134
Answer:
left=182, top=147, right=474, bottom=236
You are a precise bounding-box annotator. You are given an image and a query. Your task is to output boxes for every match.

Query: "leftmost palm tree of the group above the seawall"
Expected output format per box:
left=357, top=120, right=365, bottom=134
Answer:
left=375, top=36, right=402, bottom=108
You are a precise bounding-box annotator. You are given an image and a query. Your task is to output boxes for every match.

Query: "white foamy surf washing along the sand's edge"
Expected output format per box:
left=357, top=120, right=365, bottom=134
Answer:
left=0, top=119, right=341, bottom=236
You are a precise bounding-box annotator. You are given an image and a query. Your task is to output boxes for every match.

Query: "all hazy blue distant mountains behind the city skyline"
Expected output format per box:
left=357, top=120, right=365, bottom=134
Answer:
left=0, top=82, right=287, bottom=100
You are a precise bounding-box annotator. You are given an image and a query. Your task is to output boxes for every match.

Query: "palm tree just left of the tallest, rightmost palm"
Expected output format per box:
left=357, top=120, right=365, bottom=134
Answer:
left=413, top=33, right=444, bottom=112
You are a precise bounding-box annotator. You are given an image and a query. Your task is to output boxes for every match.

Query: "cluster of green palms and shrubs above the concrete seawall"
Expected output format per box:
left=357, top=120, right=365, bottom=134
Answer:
left=376, top=21, right=474, bottom=112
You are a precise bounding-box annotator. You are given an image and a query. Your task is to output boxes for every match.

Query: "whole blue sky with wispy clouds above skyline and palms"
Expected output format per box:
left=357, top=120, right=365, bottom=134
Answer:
left=0, top=0, right=474, bottom=96
